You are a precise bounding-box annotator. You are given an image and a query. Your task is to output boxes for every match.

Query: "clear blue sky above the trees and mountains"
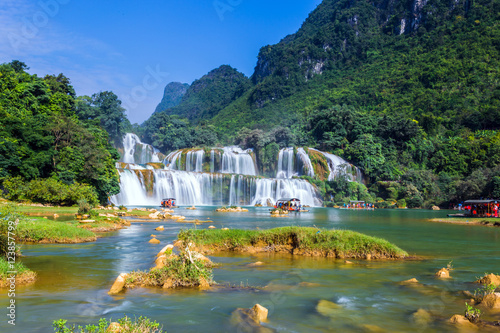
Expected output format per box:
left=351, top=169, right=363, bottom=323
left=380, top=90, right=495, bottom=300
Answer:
left=0, top=0, right=321, bottom=123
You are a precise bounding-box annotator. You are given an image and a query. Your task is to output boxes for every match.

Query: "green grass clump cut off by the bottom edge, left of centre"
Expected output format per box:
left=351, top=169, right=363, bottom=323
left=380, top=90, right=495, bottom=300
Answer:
left=52, top=316, right=163, bottom=333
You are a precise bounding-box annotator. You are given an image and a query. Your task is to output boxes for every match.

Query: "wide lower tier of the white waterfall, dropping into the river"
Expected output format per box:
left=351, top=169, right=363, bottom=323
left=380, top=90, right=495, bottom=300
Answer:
left=111, top=169, right=321, bottom=206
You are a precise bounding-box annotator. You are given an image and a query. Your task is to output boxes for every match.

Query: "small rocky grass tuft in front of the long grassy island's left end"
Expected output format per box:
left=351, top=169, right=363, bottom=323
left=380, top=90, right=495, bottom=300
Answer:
left=125, top=252, right=214, bottom=288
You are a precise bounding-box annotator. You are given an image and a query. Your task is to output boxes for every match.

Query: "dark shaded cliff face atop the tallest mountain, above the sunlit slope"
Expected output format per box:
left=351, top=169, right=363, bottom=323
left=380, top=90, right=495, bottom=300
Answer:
left=252, top=0, right=471, bottom=86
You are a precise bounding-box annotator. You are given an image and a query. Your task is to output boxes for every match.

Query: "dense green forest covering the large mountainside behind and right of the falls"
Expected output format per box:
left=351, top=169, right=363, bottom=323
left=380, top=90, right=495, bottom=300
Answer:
left=141, top=0, right=500, bottom=207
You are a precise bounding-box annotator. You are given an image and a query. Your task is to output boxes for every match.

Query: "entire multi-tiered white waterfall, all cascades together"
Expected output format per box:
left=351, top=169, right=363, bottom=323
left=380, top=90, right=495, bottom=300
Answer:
left=111, top=133, right=368, bottom=206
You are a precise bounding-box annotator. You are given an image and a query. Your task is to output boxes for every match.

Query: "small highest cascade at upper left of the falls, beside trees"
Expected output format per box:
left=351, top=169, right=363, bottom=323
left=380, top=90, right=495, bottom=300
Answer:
left=121, top=133, right=160, bottom=164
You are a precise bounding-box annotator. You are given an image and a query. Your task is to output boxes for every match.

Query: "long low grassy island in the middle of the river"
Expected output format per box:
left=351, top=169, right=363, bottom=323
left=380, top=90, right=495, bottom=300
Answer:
left=179, top=227, right=408, bottom=259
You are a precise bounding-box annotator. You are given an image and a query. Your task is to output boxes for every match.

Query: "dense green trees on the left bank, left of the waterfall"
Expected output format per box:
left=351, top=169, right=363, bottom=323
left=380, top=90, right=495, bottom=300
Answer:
left=0, top=60, right=130, bottom=205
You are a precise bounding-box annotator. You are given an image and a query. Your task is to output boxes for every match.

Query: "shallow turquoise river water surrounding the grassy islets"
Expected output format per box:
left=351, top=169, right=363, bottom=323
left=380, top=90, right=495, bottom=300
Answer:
left=0, top=207, right=500, bottom=332
